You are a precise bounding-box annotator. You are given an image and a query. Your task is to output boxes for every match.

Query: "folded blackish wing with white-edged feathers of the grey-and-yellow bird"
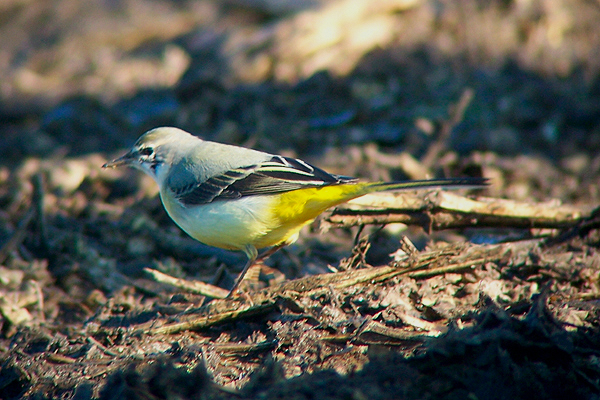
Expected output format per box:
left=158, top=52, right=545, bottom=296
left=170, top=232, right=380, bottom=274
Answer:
left=173, top=156, right=356, bottom=206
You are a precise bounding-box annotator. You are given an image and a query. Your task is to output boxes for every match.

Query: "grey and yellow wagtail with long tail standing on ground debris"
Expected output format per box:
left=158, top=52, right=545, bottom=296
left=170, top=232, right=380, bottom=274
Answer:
left=102, top=127, right=487, bottom=296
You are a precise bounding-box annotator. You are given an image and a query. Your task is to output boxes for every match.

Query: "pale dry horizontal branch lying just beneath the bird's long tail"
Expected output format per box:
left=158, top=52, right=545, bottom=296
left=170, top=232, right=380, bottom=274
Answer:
left=320, top=191, right=590, bottom=231
